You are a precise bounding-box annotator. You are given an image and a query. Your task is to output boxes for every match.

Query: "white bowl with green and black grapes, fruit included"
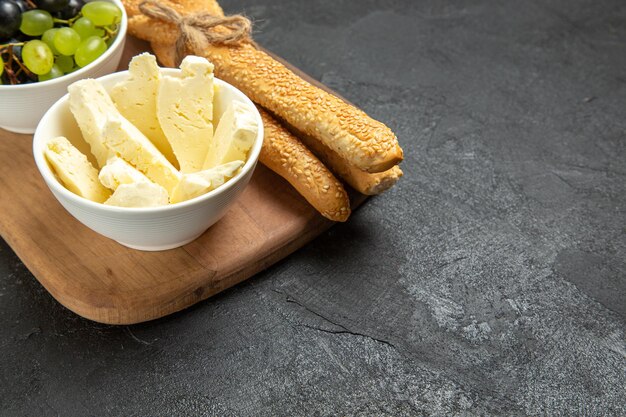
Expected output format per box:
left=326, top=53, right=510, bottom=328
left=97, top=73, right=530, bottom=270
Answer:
left=0, top=0, right=127, bottom=133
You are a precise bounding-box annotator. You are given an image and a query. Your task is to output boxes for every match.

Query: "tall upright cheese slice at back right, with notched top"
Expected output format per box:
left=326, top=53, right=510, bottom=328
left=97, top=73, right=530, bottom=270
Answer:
left=157, top=56, right=214, bottom=173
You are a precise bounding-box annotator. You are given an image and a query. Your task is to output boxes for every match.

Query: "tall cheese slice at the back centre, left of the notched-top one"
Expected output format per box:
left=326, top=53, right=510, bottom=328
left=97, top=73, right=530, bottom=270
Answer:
left=111, top=52, right=177, bottom=165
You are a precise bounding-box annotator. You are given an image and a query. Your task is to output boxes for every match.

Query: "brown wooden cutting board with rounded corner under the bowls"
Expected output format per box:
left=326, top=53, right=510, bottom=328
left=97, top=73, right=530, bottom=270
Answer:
left=0, top=38, right=363, bottom=324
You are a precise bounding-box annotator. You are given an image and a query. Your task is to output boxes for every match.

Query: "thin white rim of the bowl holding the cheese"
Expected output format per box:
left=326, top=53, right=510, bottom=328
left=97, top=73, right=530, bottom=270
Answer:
left=33, top=67, right=264, bottom=214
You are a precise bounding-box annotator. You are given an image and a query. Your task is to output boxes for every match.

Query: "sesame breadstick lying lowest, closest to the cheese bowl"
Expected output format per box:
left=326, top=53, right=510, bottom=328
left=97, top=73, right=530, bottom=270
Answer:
left=259, top=109, right=350, bottom=222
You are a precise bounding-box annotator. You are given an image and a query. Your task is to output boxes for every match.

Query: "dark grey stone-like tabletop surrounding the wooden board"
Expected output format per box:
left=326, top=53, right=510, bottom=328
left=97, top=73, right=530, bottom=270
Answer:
left=0, top=0, right=626, bottom=416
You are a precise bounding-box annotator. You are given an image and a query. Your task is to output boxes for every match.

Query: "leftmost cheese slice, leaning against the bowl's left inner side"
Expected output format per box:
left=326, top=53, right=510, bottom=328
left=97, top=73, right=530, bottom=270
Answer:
left=44, top=136, right=111, bottom=203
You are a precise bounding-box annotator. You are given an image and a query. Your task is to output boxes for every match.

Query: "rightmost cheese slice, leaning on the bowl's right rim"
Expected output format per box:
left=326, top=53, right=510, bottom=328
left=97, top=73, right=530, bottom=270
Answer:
left=203, top=101, right=259, bottom=169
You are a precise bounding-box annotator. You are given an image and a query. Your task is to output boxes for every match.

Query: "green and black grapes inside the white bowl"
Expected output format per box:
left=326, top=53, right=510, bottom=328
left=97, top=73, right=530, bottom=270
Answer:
left=0, top=0, right=122, bottom=84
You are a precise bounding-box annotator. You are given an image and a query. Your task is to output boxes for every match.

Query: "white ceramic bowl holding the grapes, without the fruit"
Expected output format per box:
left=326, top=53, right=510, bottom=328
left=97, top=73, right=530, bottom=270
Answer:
left=0, top=0, right=128, bottom=133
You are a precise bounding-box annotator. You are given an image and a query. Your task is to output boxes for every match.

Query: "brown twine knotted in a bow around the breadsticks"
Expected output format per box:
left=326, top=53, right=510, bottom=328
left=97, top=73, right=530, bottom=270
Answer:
left=139, top=0, right=254, bottom=66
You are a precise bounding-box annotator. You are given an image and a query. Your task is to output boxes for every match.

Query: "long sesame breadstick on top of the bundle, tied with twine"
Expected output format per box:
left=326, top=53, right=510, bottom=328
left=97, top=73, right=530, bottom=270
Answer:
left=124, top=0, right=402, bottom=172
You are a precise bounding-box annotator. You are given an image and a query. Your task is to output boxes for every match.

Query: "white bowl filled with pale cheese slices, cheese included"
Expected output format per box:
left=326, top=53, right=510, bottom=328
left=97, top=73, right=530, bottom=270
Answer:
left=33, top=54, right=263, bottom=251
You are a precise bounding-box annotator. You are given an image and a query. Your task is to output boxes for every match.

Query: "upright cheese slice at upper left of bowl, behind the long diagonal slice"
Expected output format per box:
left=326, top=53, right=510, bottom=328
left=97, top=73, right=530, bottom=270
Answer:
left=67, top=78, right=118, bottom=167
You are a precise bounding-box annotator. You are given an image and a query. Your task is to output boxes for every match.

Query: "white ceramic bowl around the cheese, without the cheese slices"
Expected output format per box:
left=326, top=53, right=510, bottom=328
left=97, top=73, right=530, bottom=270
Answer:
left=33, top=68, right=263, bottom=251
